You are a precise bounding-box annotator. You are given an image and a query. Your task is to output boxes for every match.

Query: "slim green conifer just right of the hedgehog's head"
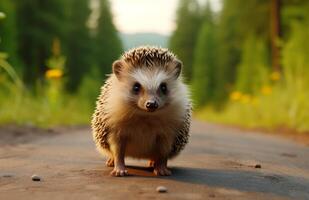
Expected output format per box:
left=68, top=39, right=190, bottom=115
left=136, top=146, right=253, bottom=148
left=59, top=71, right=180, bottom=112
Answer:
left=192, top=3, right=218, bottom=107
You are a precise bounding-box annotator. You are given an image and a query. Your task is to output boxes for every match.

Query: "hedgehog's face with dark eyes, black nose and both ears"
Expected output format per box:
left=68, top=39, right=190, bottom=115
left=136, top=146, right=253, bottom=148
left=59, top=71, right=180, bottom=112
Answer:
left=114, top=58, right=181, bottom=113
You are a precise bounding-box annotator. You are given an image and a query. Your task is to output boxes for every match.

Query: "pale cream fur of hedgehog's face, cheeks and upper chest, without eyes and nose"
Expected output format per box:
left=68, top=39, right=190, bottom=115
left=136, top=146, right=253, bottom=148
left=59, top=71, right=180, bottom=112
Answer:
left=105, top=68, right=190, bottom=135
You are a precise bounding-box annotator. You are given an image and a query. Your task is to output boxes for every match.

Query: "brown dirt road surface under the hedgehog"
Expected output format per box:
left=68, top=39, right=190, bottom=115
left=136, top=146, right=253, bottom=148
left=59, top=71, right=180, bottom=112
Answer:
left=0, top=121, right=309, bottom=200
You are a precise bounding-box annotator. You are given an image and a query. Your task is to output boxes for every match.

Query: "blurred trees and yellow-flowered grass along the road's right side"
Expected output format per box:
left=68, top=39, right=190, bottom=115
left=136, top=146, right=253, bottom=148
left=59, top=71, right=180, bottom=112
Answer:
left=170, top=0, right=309, bottom=132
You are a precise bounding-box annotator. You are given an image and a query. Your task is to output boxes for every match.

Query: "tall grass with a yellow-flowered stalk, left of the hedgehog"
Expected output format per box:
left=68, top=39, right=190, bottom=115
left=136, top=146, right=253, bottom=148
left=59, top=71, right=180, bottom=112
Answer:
left=0, top=27, right=100, bottom=127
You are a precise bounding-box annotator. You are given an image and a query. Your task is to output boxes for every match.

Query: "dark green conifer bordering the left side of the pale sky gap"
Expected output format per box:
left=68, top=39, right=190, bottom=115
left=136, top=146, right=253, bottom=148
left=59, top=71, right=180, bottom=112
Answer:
left=95, top=0, right=122, bottom=78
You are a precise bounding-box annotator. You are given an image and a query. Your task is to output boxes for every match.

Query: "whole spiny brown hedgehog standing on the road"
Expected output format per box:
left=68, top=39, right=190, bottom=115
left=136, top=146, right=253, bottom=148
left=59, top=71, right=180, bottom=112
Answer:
left=91, top=46, right=192, bottom=176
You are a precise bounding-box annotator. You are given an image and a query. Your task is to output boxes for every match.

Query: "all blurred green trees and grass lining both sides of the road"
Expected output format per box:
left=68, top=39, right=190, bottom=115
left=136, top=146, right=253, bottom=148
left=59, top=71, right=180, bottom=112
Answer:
left=0, top=0, right=309, bottom=132
